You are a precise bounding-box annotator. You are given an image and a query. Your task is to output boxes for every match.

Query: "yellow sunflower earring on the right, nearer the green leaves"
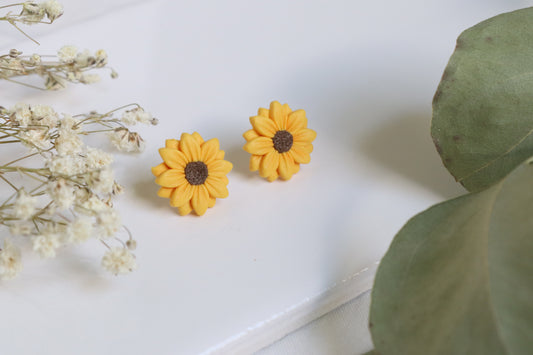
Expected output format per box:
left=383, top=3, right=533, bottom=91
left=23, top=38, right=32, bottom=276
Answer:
left=243, top=101, right=316, bottom=182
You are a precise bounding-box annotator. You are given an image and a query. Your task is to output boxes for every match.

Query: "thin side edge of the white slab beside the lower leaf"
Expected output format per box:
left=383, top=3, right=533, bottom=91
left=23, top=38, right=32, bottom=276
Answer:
left=201, top=261, right=379, bottom=355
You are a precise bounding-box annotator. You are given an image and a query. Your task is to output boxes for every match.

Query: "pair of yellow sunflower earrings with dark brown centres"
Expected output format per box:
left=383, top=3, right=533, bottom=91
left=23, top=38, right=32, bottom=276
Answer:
left=152, top=101, right=316, bottom=216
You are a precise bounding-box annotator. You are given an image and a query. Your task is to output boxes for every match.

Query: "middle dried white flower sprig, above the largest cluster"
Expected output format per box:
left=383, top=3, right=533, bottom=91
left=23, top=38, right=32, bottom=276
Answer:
left=0, top=46, right=118, bottom=90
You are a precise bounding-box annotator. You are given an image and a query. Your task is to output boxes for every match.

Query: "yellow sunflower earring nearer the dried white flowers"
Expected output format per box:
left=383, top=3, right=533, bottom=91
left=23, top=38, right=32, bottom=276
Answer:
left=152, top=132, right=233, bottom=216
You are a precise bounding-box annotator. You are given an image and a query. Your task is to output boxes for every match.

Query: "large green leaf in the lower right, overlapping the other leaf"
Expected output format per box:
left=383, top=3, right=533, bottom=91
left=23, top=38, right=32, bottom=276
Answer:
left=370, top=159, right=533, bottom=355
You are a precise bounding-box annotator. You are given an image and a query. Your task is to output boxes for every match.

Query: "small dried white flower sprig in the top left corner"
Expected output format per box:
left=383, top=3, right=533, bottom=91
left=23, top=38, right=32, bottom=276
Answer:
left=0, top=0, right=63, bottom=44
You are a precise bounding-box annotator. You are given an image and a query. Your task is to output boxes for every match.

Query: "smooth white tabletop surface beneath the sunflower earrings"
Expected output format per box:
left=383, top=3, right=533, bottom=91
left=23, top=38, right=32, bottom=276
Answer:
left=0, top=0, right=529, bottom=354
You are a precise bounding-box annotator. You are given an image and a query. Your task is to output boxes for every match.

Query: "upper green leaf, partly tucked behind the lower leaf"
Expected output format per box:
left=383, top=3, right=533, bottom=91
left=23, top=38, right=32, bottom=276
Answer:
left=431, top=8, right=533, bottom=191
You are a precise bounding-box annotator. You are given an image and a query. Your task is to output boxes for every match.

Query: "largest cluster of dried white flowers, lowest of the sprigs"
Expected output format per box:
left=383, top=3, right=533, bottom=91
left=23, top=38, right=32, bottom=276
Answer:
left=0, top=104, right=157, bottom=279
